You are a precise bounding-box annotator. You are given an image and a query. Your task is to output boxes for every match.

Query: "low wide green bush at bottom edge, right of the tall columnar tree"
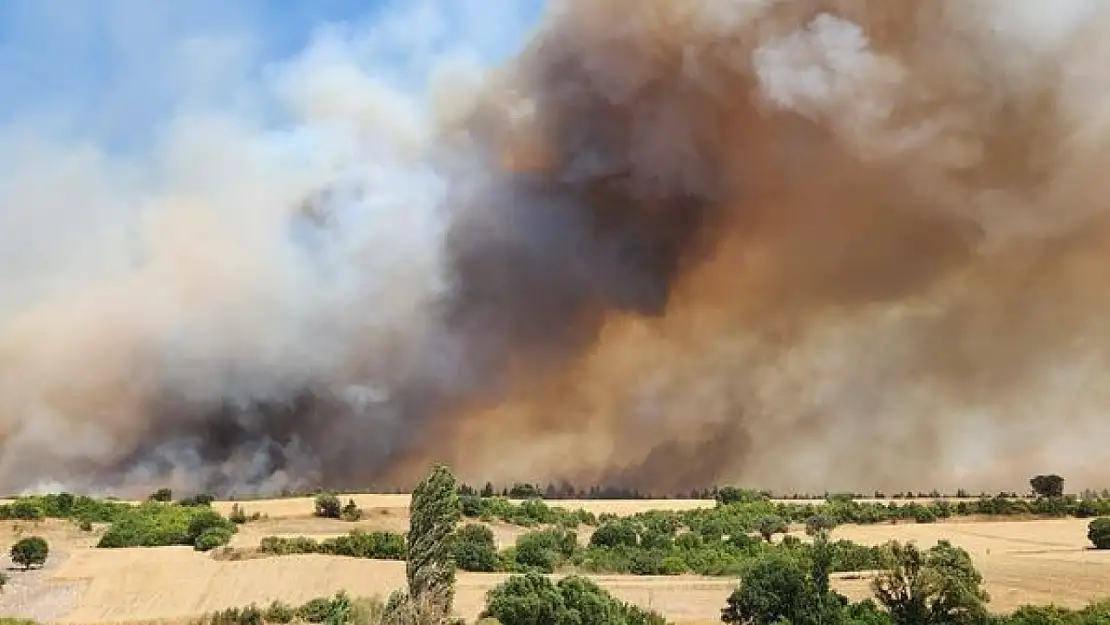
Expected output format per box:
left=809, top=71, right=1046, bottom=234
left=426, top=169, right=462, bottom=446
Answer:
left=482, top=573, right=666, bottom=625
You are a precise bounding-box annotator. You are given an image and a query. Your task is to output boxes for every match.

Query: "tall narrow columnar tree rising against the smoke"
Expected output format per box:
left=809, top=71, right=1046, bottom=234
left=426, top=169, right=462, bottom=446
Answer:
left=385, top=465, right=462, bottom=625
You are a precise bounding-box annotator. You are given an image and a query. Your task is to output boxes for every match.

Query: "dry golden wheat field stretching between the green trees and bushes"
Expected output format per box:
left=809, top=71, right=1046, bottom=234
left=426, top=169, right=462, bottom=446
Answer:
left=0, top=495, right=1110, bottom=624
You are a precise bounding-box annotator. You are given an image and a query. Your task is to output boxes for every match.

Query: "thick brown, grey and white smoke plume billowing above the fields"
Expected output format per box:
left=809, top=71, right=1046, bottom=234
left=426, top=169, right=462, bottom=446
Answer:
left=0, top=0, right=1110, bottom=499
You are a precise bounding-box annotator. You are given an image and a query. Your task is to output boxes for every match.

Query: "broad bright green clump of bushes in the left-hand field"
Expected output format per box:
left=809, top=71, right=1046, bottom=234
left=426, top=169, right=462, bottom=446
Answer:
left=97, top=502, right=236, bottom=548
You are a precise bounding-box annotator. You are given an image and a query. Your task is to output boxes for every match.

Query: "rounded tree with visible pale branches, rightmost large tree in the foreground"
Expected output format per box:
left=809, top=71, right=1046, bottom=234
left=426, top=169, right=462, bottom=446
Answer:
left=871, top=541, right=990, bottom=625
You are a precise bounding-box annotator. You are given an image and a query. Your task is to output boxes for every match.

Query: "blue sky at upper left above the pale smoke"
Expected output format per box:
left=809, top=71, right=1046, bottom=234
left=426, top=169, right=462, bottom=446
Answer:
left=0, top=0, right=544, bottom=145
